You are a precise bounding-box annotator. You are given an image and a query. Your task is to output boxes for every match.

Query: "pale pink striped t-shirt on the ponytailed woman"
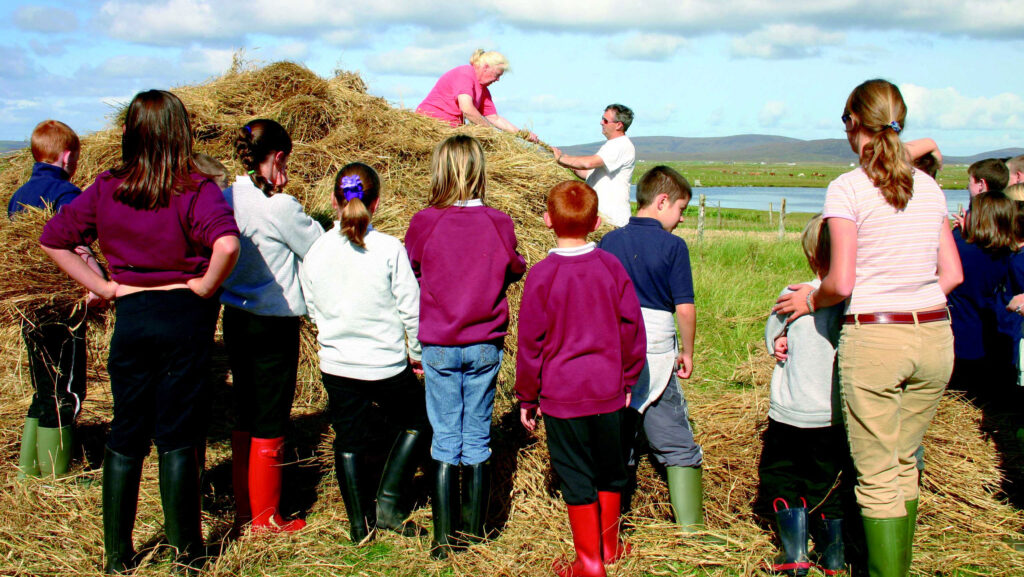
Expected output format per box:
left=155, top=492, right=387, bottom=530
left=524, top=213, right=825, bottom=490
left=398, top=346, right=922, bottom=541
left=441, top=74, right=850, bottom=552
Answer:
left=822, top=168, right=946, bottom=315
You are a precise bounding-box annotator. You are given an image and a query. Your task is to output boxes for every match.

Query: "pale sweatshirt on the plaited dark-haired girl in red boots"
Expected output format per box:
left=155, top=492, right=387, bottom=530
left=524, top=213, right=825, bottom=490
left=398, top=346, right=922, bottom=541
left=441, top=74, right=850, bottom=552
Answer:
left=220, top=176, right=324, bottom=317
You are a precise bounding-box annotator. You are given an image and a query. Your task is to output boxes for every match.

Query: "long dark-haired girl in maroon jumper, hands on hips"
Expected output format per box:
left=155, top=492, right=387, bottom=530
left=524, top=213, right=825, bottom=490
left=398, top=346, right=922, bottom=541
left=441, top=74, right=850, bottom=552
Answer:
left=39, top=90, right=239, bottom=573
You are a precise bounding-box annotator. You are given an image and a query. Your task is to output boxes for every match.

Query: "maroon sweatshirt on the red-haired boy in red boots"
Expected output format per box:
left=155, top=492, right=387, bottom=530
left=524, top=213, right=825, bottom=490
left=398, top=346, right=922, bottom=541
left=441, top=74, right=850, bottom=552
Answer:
left=515, top=245, right=647, bottom=419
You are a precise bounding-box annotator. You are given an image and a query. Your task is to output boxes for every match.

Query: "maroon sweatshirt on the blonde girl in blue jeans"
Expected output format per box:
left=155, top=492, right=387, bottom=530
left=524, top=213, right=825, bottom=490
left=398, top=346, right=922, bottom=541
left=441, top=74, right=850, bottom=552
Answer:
left=406, top=203, right=526, bottom=346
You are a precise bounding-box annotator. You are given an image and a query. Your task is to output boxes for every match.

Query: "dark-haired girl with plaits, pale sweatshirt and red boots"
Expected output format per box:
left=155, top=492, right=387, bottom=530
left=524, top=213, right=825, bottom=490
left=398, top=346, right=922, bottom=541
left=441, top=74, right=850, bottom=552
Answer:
left=220, top=119, right=324, bottom=533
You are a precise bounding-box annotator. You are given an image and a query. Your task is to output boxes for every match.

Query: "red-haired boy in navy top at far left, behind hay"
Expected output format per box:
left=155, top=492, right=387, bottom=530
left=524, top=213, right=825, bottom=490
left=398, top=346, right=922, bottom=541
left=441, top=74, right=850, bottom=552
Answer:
left=7, top=120, right=101, bottom=477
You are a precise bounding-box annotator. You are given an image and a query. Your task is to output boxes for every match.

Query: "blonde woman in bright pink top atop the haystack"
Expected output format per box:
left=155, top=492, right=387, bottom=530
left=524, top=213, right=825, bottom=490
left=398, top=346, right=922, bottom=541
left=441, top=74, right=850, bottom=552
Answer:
left=416, top=49, right=538, bottom=142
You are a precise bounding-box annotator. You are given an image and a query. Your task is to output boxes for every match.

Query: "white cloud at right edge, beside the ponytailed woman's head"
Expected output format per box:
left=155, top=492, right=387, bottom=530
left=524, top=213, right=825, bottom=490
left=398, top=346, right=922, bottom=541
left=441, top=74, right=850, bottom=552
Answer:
left=900, top=84, right=1024, bottom=131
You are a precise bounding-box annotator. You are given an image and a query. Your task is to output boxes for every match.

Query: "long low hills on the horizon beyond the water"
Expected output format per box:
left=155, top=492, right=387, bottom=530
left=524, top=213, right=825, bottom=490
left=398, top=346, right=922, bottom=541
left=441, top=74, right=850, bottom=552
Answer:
left=562, top=134, right=1024, bottom=164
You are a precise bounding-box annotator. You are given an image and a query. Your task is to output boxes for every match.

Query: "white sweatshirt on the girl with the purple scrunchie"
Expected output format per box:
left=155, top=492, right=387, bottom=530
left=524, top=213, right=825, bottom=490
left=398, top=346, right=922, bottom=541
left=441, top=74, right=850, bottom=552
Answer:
left=299, top=222, right=421, bottom=380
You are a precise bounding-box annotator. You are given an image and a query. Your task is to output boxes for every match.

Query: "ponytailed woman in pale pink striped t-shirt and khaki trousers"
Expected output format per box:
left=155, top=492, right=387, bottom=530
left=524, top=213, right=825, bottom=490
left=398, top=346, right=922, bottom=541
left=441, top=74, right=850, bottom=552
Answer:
left=775, top=80, right=963, bottom=576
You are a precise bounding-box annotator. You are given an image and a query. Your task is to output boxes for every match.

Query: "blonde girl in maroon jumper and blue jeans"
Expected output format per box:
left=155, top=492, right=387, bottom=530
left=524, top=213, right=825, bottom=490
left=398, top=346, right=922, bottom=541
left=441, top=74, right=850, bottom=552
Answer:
left=406, top=134, right=526, bottom=558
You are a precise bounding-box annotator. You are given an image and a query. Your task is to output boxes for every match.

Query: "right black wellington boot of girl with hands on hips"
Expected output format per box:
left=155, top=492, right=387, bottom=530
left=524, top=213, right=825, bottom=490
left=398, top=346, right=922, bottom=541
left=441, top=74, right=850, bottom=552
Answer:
left=160, top=447, right=205, bottom=573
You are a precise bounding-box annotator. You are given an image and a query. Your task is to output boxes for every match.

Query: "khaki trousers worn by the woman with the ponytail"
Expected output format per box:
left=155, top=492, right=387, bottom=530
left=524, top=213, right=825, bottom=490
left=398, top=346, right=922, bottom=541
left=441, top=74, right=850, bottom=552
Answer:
left=839, top=321, right=953, bottom=519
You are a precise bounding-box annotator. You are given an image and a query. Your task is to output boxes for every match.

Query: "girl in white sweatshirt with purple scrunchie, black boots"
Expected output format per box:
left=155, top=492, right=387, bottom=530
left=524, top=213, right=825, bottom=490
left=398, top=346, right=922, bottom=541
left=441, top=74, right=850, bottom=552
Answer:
left=300, top=163, right=430, bottom=543
